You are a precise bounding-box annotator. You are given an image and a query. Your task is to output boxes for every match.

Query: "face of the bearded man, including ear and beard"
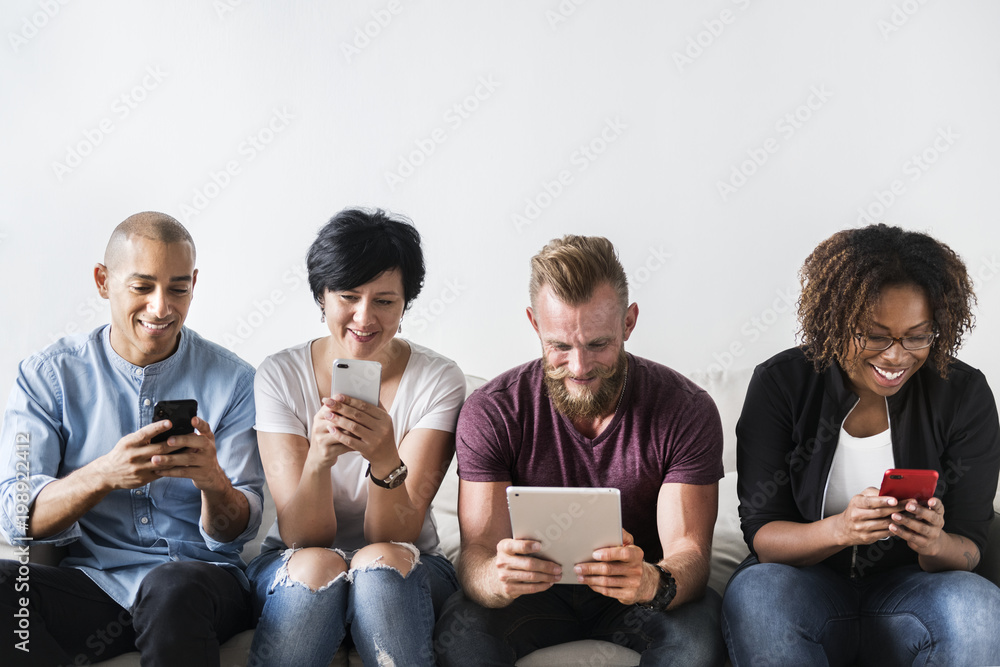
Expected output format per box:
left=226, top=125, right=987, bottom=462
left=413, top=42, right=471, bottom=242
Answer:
left=528, top=284, right=639, bottom=419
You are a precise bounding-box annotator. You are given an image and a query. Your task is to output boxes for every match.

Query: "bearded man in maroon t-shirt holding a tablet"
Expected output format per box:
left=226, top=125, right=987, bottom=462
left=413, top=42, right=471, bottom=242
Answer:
left=436, top=236, right=725, bottom=667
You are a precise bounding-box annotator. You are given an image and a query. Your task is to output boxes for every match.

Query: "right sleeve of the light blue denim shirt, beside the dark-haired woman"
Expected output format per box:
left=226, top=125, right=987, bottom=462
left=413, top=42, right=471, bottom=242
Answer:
left=198, top=371, right=264, bottom=553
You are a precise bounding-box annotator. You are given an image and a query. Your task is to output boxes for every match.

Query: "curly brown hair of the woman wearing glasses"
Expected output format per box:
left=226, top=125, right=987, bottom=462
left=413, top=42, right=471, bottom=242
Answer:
left=798, top=224, right=976, bottom=378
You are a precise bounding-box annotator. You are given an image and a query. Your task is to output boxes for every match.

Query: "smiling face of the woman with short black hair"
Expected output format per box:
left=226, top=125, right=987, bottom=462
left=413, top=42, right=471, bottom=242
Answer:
left=323, top=269, right=405, bottom=359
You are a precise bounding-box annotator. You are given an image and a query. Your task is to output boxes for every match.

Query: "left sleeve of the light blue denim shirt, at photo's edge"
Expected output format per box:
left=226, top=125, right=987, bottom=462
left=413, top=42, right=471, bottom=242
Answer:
left=0, top=359, right=81, bottom=546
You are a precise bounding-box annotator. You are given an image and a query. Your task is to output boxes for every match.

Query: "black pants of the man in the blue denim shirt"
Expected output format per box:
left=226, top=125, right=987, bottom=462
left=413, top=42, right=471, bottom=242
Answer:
left=0, top=560, right=252, bottom=667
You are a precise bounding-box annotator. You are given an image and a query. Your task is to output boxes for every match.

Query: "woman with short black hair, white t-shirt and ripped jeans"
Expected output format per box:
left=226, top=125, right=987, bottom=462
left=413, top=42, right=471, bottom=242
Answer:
left=247, top=209, right=465, bottom=666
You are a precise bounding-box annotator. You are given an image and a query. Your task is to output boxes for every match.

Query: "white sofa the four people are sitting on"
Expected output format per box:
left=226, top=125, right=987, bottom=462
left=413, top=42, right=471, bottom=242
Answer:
left=0, top=369, right=1000, bottom=667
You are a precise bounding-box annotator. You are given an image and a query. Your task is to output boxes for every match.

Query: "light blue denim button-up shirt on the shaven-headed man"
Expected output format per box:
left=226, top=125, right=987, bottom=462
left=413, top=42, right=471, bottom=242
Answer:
left=0, top=325, right=264, bottom=609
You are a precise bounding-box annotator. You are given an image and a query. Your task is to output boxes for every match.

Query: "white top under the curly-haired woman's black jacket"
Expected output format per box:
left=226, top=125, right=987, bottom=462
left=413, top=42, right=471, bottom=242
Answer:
left=824, top=426, right=893, bottom=516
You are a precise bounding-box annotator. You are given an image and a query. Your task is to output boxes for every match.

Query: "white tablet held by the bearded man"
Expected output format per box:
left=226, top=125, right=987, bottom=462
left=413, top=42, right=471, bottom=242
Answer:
left=507, top=486, right=622, bottom=584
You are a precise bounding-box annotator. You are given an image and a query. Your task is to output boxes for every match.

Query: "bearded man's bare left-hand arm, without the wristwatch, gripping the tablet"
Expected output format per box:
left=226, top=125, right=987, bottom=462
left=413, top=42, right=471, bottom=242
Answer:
left=458, top=480, right=562, bottom=607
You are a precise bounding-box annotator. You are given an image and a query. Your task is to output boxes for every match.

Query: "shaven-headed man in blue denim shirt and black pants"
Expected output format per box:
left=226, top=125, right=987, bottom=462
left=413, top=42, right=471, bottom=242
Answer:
left=0, top=212, right=264, bottom=667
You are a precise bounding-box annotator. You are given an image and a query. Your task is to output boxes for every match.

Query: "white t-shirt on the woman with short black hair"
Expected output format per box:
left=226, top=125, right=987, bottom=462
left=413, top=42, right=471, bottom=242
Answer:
left=254, top=341, right=465, bottom=555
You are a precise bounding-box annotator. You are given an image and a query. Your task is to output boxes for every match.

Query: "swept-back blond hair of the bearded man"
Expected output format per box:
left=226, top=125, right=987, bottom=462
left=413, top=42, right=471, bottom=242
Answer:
left=528, top=234, right=628, bottom=311
